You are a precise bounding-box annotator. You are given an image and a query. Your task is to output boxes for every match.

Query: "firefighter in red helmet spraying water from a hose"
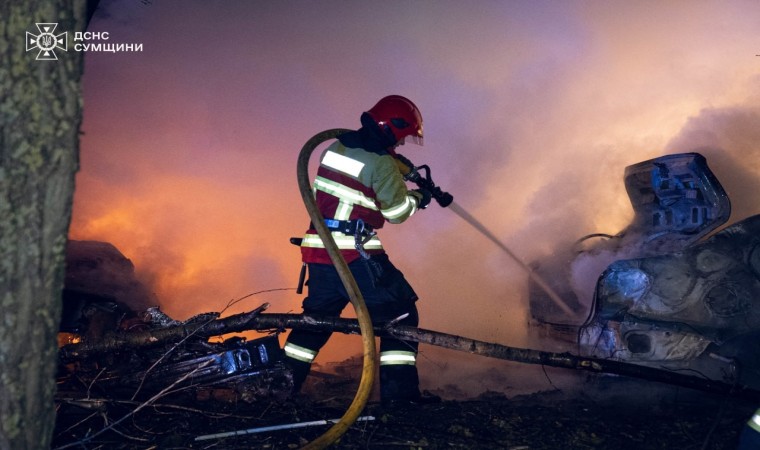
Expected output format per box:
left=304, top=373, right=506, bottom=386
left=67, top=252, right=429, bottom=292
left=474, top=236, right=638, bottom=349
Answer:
left=284, top=95, right=431, bottom=403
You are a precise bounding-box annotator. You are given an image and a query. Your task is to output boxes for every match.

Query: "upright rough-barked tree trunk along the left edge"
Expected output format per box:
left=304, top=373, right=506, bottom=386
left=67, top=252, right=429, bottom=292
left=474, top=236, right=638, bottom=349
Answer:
left=0, top=0, right=86, bottom=449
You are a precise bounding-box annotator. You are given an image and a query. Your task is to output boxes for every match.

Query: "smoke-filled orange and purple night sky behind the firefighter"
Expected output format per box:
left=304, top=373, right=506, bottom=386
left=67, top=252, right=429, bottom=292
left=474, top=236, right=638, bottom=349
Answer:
left=70, top=0, right=760, bottom=376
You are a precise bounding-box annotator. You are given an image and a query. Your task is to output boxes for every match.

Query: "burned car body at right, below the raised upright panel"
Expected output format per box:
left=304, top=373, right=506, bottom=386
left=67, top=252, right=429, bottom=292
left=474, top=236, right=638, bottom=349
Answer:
left=579, top=215, right=760, bottom=386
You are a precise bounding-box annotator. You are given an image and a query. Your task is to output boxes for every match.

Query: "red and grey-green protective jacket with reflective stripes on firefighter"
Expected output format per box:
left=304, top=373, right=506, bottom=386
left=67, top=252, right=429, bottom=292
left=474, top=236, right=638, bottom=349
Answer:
left=301, top=129, right=422, bottom=264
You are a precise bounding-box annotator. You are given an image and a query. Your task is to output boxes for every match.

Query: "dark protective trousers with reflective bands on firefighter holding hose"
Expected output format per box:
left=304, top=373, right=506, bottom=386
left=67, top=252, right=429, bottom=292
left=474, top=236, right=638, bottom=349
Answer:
left=285, top=254, right=420, bottom=402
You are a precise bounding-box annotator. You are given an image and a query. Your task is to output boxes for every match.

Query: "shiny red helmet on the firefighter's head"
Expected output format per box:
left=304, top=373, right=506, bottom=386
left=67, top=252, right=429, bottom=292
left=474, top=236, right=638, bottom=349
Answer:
left=367, top=95, right=422, bottom=145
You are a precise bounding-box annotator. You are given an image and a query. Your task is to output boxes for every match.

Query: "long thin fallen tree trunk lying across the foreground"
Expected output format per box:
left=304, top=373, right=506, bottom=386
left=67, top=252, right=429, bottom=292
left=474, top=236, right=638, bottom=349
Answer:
left=60, top=310, right=760, bottom=398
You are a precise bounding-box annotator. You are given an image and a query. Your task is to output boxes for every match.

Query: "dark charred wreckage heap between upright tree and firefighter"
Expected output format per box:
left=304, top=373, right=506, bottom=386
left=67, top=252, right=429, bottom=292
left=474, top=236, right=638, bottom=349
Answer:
left=58, top=241, right=292, bottom=404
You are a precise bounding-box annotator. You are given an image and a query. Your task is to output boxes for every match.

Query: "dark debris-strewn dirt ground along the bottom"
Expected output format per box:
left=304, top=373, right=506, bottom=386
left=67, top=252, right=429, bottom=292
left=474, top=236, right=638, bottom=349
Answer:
left=53, top=368, right=757, bottom=450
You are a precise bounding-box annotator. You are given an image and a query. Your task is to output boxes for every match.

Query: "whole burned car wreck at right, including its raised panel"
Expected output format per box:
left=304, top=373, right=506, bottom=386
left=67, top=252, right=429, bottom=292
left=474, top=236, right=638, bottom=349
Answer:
left=531, top=153, right=760, bottom=388
